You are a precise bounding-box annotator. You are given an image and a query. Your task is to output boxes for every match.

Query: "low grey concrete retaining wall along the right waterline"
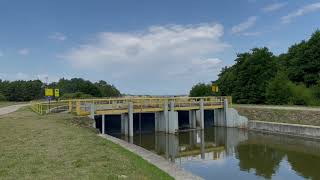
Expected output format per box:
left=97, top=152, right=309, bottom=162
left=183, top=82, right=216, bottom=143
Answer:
left=248, top=121, right=320, bottom=139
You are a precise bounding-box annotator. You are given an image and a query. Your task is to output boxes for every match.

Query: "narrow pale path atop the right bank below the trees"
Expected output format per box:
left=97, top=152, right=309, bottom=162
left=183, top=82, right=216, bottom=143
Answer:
left=233, top=104, right=320, bottom=111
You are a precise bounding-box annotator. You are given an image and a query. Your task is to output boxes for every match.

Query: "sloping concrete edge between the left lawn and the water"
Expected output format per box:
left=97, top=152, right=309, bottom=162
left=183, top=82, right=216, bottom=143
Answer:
left=98, top=134, right=203, bottom=180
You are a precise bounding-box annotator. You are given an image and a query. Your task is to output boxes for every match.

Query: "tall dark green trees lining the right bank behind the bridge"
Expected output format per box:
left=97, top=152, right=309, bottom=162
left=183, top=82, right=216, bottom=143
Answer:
left=190, top=31, right=320, bottom=105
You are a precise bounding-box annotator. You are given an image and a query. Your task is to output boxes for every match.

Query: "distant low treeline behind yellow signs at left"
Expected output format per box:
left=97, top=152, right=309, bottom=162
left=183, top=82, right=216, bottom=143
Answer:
left=0, top=78, right=121, bottom=101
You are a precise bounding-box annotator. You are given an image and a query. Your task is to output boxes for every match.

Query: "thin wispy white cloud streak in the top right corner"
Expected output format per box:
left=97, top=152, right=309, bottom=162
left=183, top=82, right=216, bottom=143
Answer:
left=281, top=2, right=320, bottom=23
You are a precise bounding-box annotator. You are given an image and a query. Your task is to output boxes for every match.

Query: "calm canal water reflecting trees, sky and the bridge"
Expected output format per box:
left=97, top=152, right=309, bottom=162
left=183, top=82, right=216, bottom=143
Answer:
left=109, top=127, right=320, bottom=180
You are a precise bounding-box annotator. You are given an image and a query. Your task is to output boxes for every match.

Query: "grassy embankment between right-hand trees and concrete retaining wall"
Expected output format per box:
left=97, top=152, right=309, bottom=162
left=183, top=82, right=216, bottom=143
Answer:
left=233, top=105, right=320, bottom=126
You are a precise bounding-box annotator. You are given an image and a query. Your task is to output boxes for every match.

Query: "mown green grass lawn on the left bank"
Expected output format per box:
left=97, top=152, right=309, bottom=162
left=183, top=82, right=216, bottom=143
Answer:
left=0, top=107, right=172, bottom=179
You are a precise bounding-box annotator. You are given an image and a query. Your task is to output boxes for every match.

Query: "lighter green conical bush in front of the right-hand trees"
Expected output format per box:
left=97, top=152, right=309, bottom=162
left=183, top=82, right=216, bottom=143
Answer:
left=266, top=71, right=291, bottom=105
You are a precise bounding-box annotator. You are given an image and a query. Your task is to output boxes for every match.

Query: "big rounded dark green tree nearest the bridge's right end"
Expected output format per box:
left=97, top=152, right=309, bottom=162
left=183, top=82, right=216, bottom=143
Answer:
left=218, top=48, right=277, bottom=104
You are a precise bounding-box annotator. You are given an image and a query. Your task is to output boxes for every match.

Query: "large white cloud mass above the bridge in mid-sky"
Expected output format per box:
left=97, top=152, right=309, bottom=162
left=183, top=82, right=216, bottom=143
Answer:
left=62, top=23, right=229, bottom=93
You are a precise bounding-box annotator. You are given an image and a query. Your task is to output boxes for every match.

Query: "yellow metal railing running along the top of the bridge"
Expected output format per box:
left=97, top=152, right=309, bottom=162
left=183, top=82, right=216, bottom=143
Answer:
left=31, top=96, right=232, bottom=115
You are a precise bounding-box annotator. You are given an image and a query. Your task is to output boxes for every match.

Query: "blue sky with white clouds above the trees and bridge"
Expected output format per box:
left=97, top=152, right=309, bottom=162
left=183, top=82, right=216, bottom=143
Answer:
left=0, top=0, right=320, bottom=95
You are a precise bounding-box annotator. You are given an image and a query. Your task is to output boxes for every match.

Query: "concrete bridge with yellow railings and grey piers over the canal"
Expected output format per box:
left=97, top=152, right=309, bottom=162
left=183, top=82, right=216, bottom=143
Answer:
left=32, top=96, right=246, bottom=136
